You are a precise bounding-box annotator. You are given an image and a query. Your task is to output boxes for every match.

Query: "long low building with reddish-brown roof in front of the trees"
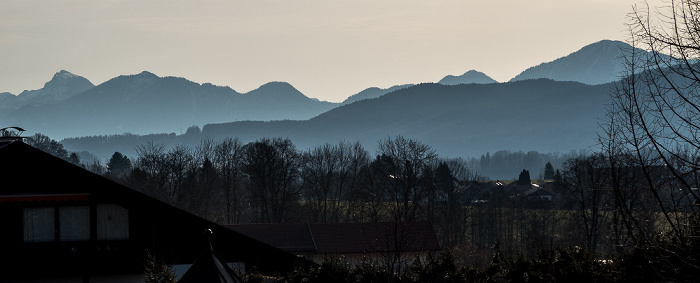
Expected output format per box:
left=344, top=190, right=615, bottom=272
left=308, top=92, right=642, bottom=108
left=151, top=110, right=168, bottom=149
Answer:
left=226, top=221, right=440, bottom=264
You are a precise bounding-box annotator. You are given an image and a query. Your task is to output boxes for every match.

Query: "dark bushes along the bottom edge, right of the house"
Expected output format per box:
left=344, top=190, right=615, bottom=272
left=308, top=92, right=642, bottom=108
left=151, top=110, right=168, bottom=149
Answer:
left=246, top=243, right=700, bottom=283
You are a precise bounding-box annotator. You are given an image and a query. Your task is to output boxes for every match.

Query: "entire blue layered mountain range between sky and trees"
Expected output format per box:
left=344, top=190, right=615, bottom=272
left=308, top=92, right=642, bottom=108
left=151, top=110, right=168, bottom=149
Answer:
left=0, top=40, right=652, bottom=161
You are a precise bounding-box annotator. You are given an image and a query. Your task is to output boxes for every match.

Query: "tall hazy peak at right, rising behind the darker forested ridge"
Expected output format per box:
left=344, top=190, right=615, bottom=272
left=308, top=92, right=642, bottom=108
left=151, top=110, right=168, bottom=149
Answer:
left=511, top=40, right=632, bottom=84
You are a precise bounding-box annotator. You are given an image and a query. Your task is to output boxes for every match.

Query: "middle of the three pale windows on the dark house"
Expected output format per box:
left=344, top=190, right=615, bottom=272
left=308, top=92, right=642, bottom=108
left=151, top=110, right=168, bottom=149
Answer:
left=58, top=206, right=90, bottom=241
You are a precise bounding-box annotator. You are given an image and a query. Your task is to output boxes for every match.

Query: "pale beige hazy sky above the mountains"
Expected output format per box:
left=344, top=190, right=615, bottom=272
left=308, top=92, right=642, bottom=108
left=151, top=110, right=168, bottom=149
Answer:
left=0, top=0, right=653, bottom=101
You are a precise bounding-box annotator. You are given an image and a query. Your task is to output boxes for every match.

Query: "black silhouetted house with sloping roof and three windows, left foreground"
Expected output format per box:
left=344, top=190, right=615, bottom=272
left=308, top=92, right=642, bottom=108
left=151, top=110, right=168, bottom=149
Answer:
left=0, top=139, right=306, bottom=282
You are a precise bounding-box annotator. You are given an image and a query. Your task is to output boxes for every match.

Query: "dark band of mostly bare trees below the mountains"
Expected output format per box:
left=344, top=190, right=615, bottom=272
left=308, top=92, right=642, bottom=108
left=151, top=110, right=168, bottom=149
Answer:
left=28, top=130, right=693, bottom=280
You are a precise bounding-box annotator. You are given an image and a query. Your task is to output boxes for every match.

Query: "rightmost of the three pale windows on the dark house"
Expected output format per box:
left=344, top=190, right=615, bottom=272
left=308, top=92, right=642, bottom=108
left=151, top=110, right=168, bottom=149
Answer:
left=97, top=204, right=129, bottom=240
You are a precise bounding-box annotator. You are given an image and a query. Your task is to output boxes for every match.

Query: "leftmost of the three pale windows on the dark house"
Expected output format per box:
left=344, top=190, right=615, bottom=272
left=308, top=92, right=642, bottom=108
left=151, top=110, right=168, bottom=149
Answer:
left=24, top=207, right=56, bottom=242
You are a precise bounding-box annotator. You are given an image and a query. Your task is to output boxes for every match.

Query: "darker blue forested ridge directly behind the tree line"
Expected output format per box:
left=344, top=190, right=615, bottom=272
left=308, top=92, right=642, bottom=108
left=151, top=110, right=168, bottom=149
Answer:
left=63, top=80, right=609, bottom=160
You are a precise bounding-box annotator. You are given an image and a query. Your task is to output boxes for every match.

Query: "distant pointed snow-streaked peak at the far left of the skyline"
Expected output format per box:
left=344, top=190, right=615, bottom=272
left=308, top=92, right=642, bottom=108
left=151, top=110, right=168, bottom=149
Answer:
left=0, top=70, right=95, bottom=110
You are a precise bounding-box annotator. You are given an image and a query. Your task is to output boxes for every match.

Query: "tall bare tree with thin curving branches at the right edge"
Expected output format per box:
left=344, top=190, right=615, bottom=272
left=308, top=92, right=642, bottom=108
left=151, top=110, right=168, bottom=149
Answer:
left=603, top=0, right=700, bottom=278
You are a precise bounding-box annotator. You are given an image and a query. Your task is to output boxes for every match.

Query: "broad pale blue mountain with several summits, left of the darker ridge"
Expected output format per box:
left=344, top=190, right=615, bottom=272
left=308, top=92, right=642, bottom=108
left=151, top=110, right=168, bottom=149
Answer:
left=0, top=72, right=337, bottom=139
